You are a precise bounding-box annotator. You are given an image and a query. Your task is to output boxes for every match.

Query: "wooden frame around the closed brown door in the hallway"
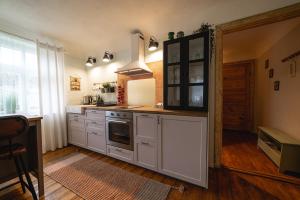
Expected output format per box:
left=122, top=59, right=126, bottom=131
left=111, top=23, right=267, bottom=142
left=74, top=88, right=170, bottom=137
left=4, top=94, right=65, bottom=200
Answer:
left=222, top=59, right=255, bottom=132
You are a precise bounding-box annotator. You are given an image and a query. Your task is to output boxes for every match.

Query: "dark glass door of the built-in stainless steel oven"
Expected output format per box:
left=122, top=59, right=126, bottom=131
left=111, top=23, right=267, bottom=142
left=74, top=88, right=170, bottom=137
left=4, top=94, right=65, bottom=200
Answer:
left=106, top=118, right=133, bottom=150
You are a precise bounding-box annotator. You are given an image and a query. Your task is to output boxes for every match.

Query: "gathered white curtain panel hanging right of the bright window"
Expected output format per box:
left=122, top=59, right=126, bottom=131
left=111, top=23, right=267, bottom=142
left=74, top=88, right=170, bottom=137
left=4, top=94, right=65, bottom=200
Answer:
left=37, top=42, right=67, bottom=152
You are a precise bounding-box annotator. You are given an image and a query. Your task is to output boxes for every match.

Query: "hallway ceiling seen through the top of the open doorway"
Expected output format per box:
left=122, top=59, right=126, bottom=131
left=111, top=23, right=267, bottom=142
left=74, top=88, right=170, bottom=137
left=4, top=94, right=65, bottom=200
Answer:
left=223, top=17, right=300, bottom=62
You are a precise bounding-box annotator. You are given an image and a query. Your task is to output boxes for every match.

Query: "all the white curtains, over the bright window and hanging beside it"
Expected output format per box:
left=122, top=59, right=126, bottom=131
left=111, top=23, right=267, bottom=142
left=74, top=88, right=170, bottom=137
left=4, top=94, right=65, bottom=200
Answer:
left=0, top=31, right=67, bottom=152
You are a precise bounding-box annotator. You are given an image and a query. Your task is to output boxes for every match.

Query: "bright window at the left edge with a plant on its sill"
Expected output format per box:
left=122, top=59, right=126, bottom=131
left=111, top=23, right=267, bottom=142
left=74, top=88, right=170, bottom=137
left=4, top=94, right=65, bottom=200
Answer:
left=0, top=32, right=40, bottom=115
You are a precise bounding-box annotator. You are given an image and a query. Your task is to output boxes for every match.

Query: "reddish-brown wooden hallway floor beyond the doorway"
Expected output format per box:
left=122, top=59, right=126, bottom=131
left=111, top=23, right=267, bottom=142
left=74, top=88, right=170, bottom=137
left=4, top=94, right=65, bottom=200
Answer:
left=222, top=131, right=300, bottom=185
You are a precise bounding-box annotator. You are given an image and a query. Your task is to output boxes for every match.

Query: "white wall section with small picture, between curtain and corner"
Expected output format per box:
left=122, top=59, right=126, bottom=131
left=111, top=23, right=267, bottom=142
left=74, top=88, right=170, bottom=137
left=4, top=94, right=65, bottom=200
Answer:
left=65, top=54, right=89, bottom=105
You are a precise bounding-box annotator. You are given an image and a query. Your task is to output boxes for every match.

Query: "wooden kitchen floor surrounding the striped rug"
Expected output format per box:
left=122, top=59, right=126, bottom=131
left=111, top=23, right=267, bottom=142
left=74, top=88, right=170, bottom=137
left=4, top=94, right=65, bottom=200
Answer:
left=0, top=146, right=300, bottom=200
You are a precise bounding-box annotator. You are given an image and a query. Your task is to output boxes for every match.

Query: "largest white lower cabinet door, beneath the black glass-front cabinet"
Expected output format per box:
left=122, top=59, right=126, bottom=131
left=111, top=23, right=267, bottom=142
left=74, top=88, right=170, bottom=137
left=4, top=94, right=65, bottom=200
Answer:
left=158, top=115, right=208, bottom=187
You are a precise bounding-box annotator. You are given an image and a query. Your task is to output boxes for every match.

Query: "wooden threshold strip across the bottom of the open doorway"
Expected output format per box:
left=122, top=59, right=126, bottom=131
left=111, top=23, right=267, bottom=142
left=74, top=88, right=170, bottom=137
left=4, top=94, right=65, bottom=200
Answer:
left=222, top=165, right=300, bottom=185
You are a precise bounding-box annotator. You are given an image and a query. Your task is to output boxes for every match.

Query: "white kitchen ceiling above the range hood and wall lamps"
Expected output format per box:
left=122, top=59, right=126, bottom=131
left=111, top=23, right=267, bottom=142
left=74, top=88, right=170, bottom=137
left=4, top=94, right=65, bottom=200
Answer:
left=0, top=0, right=298, bottom=58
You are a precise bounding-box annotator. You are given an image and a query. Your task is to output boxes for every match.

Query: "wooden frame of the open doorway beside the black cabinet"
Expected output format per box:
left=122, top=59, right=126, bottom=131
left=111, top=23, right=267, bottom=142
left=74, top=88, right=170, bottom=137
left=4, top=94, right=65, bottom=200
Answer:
left=214, top=3, right=300, bottom=167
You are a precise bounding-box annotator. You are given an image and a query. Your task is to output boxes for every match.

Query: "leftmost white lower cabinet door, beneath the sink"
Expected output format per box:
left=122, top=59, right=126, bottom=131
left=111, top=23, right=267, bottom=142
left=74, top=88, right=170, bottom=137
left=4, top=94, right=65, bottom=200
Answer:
left=68, top=114, right=86, bottom=147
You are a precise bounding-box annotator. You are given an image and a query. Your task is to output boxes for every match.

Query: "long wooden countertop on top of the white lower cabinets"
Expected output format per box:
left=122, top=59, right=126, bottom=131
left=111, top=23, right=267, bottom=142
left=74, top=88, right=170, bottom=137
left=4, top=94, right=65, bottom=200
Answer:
left=75, top=105, right=208, bottom=117
